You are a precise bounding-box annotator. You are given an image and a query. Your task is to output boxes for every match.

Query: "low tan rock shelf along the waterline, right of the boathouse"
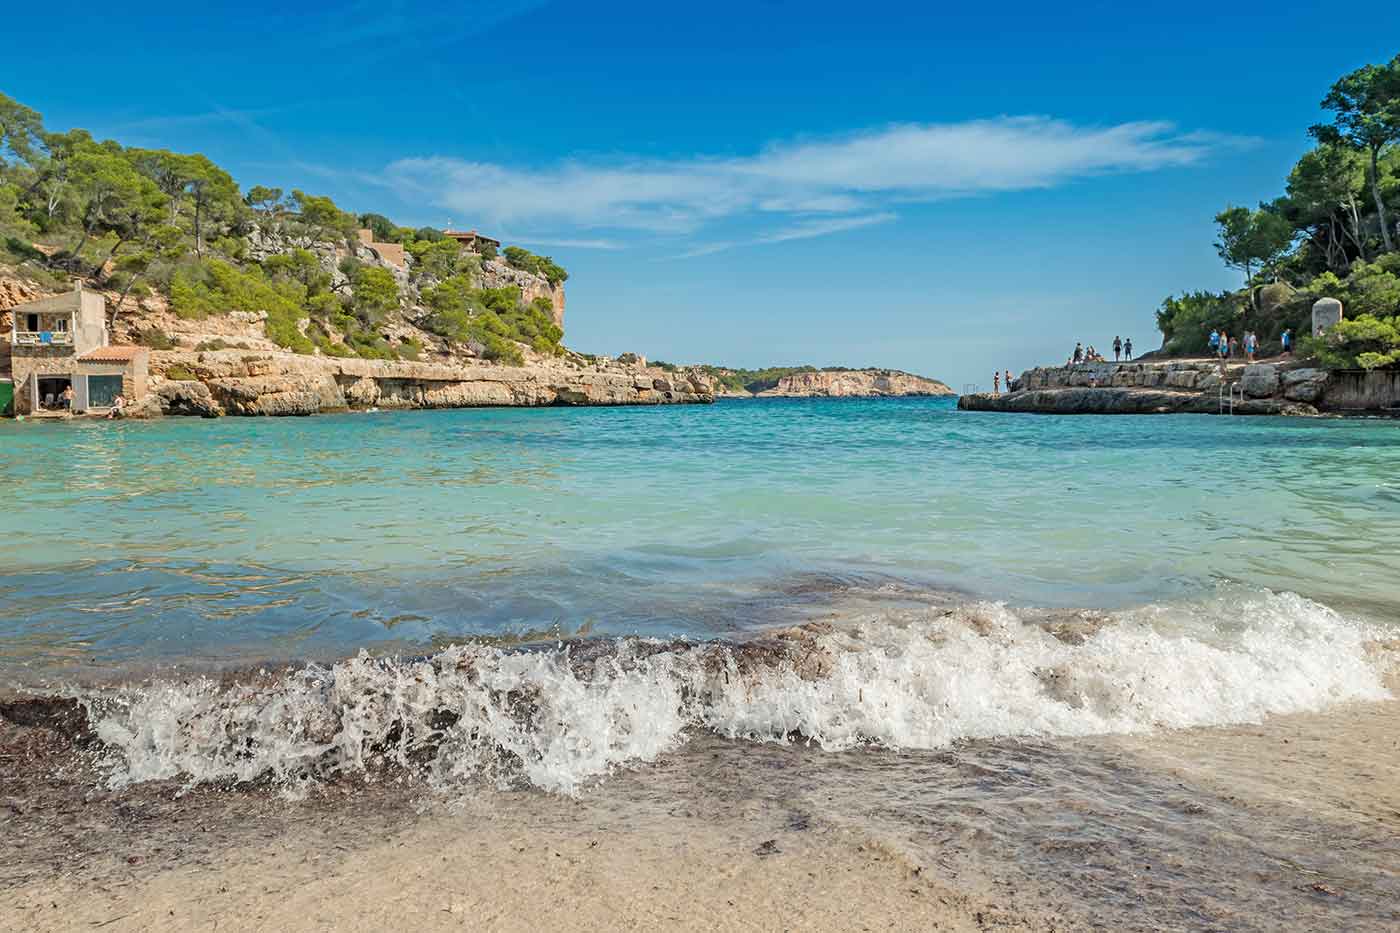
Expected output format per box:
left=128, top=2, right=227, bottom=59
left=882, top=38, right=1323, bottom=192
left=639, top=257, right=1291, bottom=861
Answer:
left=151, top=350, right=714, bottom=416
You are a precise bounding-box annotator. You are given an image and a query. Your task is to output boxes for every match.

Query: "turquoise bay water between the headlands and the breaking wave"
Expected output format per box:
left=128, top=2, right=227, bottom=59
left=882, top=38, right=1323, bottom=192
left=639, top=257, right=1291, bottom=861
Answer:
left=0, top=399, right=1400, bottom=678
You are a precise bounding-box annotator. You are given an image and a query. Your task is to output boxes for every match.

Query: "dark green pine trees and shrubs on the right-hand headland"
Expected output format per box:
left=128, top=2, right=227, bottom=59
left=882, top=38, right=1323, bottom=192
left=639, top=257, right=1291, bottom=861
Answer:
left=1156, top=55, right=1400, bottom=368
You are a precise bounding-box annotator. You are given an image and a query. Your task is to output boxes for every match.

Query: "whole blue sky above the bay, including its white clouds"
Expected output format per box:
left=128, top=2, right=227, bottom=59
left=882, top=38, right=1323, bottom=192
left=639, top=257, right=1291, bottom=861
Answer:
left=0, top=0, right=1400, bottom=389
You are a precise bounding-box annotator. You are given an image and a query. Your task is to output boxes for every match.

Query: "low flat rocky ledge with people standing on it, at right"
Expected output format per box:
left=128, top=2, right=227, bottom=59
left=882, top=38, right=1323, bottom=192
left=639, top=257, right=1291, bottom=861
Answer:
left=958, top=360, right=1400, bottom=415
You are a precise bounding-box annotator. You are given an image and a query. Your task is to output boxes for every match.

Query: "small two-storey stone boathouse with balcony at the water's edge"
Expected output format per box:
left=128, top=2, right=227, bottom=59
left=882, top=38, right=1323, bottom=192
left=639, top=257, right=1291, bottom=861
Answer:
left=10, top=283, right=148, bottom=416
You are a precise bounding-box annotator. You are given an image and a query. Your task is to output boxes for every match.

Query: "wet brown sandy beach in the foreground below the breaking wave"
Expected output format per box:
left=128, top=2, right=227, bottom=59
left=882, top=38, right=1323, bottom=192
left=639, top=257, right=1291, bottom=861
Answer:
left=0, top=686, right=1400, bottom=930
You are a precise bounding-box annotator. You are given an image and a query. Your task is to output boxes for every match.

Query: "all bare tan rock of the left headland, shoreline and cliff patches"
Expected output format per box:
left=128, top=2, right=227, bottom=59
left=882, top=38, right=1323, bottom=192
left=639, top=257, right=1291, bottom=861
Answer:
left=0, top=252, right=715, bottom=417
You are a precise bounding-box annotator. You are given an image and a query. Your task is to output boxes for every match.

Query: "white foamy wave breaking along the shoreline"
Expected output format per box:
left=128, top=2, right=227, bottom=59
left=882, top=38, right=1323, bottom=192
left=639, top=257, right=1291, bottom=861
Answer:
left=84, top=594, right=1394, bottom=793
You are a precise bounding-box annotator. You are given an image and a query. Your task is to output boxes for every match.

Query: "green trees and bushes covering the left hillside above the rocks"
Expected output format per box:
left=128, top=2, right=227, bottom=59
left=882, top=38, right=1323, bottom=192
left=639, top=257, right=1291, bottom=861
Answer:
left=0, top=94, right=568, bottom=361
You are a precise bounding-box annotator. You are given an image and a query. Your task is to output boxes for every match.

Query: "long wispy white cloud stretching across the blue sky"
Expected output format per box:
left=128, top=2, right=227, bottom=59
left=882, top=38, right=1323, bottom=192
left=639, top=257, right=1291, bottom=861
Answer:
left=385, top=116, right=1228, bottom=255
